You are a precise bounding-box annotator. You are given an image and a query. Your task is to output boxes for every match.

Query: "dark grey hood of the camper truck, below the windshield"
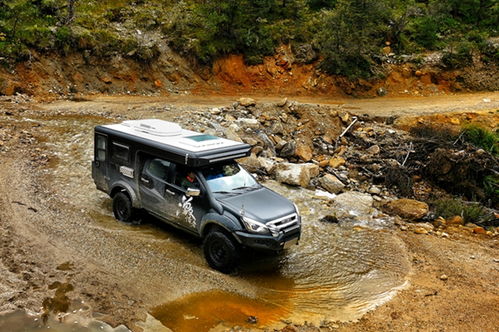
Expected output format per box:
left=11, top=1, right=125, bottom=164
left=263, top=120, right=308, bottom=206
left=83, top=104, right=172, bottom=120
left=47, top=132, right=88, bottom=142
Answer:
left=218, top=187, right=296, bottom=223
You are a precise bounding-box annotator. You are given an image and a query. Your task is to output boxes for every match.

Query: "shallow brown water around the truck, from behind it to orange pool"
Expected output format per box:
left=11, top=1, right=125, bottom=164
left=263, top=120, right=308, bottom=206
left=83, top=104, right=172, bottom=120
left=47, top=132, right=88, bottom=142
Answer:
left=0, top=109, right=410, bottom=331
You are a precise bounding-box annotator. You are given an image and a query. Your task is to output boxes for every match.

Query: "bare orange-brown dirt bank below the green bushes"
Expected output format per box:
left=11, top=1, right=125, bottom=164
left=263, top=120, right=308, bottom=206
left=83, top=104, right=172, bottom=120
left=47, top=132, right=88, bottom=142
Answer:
left=0, top=46, right=499, bottom=99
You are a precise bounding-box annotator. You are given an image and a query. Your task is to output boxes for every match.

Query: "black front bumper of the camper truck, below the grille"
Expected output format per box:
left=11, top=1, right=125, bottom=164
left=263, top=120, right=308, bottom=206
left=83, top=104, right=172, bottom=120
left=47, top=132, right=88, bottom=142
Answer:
left=234, top=228, right=301, bottom=251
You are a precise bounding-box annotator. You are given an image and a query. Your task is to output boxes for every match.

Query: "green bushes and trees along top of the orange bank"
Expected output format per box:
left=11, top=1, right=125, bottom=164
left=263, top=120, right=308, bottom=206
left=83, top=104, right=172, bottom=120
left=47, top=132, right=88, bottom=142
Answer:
left=0, top=0, right=499, bottom=78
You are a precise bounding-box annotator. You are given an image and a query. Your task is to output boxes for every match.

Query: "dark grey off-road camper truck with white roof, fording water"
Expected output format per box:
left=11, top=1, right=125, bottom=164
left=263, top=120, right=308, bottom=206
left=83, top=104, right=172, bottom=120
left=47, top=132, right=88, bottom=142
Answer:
left=92, top=119, right=301, bottom=273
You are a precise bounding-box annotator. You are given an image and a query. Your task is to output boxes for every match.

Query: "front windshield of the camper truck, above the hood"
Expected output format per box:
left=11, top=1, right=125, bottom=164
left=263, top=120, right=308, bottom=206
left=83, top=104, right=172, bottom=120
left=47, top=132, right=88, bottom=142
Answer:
left=201, top=162, right=260, bottom=193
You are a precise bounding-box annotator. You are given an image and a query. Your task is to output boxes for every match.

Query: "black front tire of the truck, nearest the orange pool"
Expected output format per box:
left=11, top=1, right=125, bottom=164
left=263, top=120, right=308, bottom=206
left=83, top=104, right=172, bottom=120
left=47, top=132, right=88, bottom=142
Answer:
left=203, top=230, right=239, bottom=274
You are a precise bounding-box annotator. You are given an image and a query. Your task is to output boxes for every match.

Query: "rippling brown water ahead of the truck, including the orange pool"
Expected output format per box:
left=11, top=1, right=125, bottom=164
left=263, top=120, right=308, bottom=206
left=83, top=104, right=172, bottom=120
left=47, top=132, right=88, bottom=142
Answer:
left=151, top=182, right=410, bottom=331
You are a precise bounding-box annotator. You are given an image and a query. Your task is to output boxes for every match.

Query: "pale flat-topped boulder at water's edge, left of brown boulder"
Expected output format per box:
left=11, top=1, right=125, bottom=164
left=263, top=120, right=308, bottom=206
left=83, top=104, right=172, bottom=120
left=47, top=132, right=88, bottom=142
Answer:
left=333, top=191, right=376, bottom=220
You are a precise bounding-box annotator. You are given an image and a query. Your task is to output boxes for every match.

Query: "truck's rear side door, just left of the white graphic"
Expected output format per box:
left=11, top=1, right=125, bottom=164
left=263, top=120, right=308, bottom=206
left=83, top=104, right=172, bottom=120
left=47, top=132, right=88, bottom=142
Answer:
left=139, top=158, right=179, bottom=222
